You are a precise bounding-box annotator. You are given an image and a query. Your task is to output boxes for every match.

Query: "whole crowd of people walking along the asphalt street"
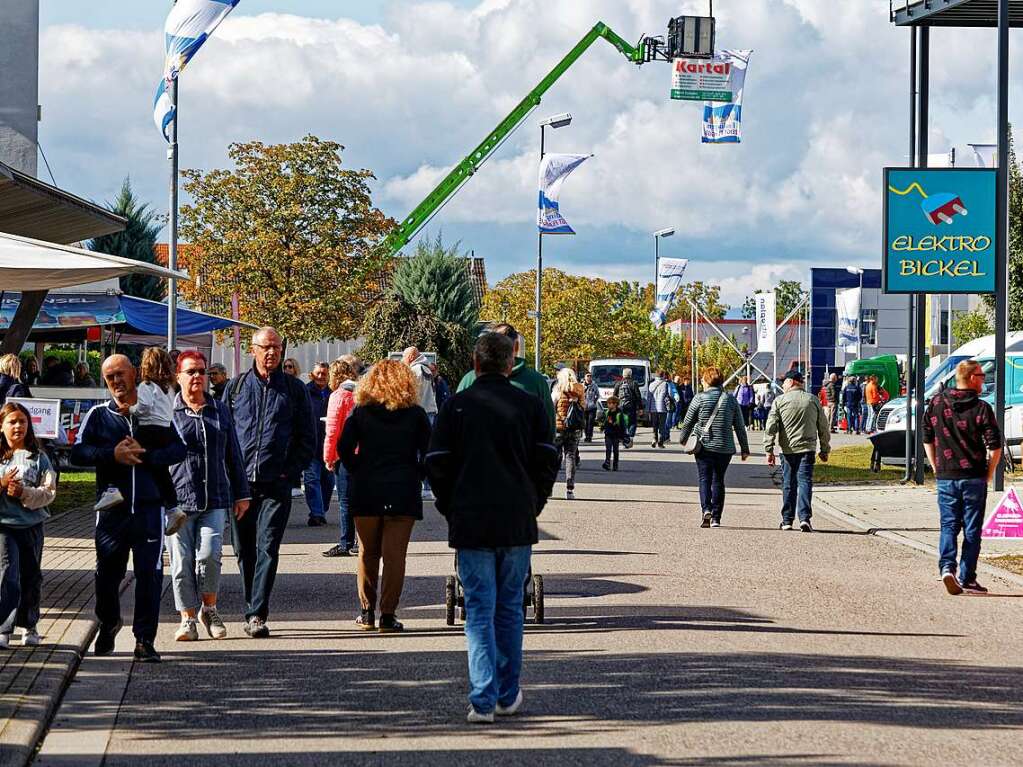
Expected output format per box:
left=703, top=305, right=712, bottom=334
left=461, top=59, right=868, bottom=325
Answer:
left=0, top=331, right=1002, bottom=722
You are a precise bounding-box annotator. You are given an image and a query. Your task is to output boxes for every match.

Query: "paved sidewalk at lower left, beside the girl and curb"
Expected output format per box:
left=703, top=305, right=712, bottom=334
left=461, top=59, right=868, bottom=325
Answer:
left=0, top=509, right=108, bottom=767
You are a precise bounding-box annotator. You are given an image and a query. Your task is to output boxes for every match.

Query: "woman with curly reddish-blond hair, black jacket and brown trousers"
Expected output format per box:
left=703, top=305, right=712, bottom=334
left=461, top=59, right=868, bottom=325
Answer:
left=339, top=360, right=430, bottom=633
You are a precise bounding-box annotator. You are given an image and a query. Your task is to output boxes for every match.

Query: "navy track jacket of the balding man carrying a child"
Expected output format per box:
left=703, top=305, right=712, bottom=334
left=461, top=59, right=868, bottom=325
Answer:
left=71, top=400, right=185, bottom=513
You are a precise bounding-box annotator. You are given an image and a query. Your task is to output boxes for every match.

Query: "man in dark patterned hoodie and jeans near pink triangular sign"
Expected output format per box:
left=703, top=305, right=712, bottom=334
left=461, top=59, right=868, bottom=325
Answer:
left=924, top=360, right=1002, bottom=594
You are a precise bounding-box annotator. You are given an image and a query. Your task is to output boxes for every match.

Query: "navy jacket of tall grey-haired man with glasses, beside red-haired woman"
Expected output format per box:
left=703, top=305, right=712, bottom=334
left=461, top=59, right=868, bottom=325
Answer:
left=224, top=365, right=316, bottom=486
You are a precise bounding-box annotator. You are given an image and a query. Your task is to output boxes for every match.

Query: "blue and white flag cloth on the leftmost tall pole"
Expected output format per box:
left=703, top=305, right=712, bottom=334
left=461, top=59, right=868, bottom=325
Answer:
left=152, top=0, right=239, bottom=141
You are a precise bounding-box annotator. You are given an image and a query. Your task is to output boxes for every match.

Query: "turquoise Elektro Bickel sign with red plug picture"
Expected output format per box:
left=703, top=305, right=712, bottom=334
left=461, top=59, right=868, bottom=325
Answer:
left=884, top=168, right=997, bottom=294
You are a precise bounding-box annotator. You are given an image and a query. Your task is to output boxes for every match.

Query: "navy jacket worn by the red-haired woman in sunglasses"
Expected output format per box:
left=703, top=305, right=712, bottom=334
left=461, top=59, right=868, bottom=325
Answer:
left=171, top=394, right=250, bottom=513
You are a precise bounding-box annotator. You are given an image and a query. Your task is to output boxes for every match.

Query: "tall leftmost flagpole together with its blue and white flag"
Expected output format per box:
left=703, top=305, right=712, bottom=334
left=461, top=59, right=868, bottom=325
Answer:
left=152, top=0, right=239, bottom=350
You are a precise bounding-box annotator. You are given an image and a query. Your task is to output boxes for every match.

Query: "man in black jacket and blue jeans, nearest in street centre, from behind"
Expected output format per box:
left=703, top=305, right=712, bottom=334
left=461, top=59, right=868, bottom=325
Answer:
left=427, top=332, right=558, bottom=723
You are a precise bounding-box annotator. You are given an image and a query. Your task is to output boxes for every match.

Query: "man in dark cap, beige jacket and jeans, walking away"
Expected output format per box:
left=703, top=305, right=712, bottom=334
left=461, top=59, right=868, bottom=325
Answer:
left=764, top=370, right=831, bottom=533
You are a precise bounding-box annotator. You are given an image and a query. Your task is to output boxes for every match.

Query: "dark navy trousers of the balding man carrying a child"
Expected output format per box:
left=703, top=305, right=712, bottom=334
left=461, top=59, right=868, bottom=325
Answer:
left=96, top=501, right=164, bottom=642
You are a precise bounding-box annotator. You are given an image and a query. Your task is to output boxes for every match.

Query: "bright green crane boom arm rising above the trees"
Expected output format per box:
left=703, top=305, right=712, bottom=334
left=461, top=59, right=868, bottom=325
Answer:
left=385, top=21, right=644, bottom=256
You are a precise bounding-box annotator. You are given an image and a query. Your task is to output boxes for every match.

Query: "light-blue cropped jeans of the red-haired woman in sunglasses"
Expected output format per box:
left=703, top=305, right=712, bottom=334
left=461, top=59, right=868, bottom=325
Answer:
left=167, top=508, right=227, bottom=613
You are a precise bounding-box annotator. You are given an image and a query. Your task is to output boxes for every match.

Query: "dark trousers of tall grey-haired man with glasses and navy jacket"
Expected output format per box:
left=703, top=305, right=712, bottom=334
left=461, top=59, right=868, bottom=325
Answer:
left=231, top=482, right=292, bottom=621
